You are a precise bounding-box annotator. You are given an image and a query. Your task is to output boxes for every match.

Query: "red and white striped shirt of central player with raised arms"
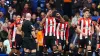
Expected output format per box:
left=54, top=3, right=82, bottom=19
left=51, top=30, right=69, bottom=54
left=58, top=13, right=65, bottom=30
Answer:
left=44, top=17, right=56, bottom=36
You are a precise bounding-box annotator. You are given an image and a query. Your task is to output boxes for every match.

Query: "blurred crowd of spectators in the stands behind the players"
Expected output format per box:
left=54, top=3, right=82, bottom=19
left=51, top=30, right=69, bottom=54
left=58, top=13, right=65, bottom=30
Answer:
left=0, top=0, right=100, bottom=54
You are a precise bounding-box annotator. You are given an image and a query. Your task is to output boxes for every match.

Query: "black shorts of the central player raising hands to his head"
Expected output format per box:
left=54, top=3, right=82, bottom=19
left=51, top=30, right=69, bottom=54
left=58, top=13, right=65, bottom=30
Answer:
left=44, top=36, right=56, bottom=48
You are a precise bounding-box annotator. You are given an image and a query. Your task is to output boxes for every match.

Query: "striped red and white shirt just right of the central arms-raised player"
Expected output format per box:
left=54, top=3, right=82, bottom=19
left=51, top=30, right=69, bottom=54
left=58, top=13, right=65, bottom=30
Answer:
left=56, top=22, right=68, bottom=40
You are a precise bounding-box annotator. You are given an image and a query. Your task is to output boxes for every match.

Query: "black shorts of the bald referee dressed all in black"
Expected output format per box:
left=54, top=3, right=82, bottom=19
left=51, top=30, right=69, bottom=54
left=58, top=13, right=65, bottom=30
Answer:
left=22, top=37, right=37, bottom=50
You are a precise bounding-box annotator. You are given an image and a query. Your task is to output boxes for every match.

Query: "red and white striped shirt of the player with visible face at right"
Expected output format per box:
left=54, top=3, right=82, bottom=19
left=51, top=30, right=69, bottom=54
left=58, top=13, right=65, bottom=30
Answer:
left=78, top=18, right=92, bottom=39
